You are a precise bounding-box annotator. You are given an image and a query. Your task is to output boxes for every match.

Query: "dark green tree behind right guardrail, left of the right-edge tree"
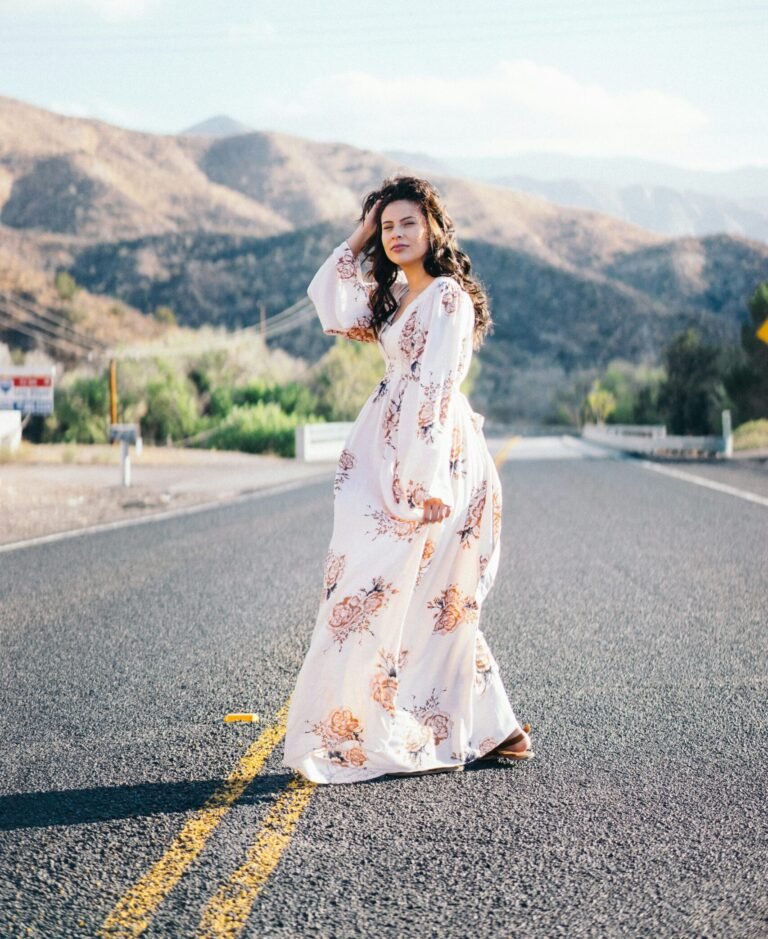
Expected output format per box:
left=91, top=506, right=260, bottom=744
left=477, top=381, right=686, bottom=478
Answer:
left=659, top=327, right=731, bottom=434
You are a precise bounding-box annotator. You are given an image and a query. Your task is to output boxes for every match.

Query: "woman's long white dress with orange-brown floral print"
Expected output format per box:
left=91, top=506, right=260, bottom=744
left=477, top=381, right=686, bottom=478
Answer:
left=283, top=242, right=518, bottom=783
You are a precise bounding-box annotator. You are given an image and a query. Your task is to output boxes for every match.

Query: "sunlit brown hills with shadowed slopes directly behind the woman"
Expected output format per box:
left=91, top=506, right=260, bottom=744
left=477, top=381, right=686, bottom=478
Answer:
left=0, top=98, right=768, bottom=419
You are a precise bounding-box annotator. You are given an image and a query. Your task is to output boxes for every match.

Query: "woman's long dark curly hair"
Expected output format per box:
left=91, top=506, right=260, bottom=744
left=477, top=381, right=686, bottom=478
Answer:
left=360, top=176, right=493, bottom=349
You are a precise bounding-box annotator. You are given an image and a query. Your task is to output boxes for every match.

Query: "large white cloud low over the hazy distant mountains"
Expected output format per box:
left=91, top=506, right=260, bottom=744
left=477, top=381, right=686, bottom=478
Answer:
left=251, top=59, right=709, bottom=159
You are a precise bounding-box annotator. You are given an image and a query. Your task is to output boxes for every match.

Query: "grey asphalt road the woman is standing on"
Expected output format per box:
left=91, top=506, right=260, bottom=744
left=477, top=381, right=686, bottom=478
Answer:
left=0, top=442, right=768, bottom=939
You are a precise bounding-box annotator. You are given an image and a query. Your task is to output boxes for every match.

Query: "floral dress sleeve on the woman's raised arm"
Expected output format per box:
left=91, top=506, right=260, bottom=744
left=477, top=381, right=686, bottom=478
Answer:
left=307, top=241, right=376, bottom=342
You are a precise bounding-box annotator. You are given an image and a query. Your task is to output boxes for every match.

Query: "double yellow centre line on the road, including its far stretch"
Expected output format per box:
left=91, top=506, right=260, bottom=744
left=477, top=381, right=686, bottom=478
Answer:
left=98, top=437, right=521, bottom=939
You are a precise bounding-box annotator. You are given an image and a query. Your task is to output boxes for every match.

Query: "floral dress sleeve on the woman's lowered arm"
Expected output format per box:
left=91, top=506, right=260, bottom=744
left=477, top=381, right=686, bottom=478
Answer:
left=393, top=278, right=475, bottom=520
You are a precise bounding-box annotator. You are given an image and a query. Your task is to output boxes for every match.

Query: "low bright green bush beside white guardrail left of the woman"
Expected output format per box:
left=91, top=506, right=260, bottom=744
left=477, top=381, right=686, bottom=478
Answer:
left=203, top=401, right=322, bottom=457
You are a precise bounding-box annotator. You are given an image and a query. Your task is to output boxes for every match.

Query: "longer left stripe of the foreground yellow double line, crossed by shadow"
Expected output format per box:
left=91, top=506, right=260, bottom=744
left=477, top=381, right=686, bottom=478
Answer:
left=98, top=703, right=288, bottom=939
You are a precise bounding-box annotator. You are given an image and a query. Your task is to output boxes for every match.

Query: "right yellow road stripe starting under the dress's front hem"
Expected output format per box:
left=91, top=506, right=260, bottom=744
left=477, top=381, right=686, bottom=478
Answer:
left=197, top=778, right=317, bottom=939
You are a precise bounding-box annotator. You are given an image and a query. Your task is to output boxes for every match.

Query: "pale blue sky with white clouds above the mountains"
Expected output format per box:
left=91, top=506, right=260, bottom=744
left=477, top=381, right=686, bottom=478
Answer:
left=0, top=0, right=768, bottom=170
